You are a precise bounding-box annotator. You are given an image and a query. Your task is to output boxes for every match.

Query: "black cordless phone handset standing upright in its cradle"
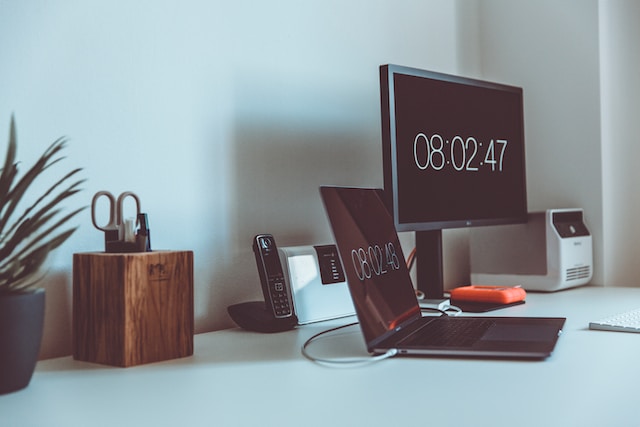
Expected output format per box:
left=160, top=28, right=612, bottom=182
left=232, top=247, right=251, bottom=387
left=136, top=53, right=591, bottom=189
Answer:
left=253, top=234, right=293, bottom=318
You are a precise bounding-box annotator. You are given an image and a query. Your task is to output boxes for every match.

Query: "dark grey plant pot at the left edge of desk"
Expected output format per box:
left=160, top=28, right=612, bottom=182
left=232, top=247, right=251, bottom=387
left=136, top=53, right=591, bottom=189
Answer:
left=0, top=289, right=44, bottom=394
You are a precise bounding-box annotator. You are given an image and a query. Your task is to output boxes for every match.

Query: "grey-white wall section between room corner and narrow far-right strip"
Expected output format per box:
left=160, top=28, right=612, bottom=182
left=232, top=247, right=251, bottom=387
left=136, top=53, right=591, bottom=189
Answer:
left=460, top=0, right=604, bottom=284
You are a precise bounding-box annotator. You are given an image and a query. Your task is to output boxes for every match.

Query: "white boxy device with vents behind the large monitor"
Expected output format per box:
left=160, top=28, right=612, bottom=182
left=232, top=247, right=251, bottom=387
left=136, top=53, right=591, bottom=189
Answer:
left=469, top=209, right=593, bottom=292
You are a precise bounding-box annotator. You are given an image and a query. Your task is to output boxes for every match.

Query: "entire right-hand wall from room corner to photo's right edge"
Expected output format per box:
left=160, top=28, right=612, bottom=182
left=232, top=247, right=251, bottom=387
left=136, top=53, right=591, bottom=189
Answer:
left=470, top=0, right=640, bottom=286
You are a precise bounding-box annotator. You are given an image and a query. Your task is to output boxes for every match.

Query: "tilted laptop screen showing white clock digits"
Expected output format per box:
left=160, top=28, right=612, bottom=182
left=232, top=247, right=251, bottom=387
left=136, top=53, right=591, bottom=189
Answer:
left=320, top=187, right=421, bottom=343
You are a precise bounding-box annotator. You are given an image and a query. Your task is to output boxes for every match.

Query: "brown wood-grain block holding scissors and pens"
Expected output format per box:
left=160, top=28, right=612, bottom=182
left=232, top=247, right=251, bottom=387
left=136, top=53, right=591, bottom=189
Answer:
left=73, top=251, right=194, bottom=367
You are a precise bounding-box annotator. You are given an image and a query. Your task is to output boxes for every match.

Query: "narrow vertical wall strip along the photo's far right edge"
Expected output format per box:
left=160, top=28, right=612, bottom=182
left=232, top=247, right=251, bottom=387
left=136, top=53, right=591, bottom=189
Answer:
left=599, top=0, right=640, bottom=286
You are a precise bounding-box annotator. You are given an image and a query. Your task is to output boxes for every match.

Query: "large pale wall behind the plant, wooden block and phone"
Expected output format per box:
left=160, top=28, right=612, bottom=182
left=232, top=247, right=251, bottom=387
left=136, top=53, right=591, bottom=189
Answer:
left=0, top=0, right=457, bottom=357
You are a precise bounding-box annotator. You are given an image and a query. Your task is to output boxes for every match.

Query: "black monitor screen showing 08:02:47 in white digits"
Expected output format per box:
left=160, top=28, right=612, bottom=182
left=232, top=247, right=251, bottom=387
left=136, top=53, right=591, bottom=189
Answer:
left=392, top=73, right=526, bottom=226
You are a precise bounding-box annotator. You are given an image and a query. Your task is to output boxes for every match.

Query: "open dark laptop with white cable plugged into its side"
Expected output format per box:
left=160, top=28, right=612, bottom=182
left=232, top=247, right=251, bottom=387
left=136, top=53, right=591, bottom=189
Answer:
left=320, top=187, right=566, bottom=359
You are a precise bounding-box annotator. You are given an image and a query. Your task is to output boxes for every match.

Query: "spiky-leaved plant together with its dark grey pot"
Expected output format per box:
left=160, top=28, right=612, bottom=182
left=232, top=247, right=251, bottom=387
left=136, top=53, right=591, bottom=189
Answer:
left=0, top=116, right=84, bottom=394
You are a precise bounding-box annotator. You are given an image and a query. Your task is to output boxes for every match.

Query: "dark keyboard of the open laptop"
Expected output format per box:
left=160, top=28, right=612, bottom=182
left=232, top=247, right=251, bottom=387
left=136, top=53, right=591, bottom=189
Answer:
left=400, top=317, right=494, bottom=347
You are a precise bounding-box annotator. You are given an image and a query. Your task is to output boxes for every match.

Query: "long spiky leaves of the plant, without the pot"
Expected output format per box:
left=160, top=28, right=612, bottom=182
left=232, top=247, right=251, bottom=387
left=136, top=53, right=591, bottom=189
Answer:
left=0, top=116, right=85, bottom=294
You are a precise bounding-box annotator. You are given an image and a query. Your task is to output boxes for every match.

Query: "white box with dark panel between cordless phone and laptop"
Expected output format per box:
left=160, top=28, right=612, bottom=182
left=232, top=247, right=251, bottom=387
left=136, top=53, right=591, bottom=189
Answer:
left=279, top=245, right=355, bottom=325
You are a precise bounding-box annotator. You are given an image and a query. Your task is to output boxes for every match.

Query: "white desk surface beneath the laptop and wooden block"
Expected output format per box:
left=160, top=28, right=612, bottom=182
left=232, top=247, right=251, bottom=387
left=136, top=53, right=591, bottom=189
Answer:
left=0, top=287, right=640, bottom=426
